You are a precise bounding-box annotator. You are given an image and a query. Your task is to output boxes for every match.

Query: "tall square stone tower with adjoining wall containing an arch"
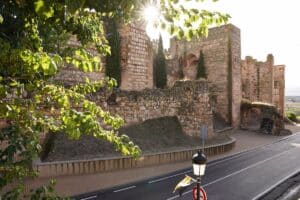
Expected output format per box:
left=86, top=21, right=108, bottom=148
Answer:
left=168, top=24, right=242, bottom=126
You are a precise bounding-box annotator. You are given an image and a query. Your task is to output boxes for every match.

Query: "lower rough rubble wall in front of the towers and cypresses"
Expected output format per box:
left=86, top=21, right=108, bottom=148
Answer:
left=90, top=81, right=213, bottom=138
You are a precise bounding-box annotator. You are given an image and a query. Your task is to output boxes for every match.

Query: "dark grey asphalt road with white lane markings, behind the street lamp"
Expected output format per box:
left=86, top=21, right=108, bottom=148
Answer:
left=75, top=134, right=300, bottom=200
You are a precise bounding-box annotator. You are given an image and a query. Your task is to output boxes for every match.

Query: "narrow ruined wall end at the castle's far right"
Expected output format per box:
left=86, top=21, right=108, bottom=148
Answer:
left=273, top=65, right=285, bottom=115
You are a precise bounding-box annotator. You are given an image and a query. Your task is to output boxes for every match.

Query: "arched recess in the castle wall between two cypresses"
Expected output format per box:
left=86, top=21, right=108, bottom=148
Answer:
left=183, top=54, right=198, bottom=80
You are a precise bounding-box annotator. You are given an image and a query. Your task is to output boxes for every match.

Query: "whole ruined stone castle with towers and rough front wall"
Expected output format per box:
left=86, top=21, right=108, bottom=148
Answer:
left=57, top=24, right=285, bottom=137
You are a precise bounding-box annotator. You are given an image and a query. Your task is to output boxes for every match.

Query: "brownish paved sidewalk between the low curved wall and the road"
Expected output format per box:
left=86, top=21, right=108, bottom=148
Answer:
left=26, top=125, right=300, bottom=196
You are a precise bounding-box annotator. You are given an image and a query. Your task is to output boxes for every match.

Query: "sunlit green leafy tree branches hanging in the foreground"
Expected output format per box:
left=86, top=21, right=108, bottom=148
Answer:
left=0, top=0, right=229, bottom=199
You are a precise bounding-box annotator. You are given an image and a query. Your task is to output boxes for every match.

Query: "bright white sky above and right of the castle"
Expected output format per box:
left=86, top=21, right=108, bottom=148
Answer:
left=145, top=0, right=300, bottom=96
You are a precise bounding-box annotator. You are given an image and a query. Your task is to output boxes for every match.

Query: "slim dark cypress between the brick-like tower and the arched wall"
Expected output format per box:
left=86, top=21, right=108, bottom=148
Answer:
left=153, top=35, right=167, bottom=88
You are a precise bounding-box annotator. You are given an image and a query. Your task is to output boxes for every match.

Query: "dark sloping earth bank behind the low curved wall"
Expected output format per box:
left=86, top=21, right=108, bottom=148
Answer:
left=45, top=117, right=230, bottom=161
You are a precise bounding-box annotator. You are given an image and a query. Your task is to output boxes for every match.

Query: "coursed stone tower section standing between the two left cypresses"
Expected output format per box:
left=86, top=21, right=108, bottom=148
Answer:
left=120, top=25, right=153, bottom=90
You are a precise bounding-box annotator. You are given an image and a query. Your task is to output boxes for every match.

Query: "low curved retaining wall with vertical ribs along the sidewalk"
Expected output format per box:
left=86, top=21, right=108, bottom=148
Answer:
left=33, top=138, right=235, bottom=177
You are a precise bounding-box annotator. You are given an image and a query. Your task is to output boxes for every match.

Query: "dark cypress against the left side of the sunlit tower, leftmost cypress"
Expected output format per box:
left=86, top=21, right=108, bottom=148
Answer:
left=105, top=19, right=121, bottom=87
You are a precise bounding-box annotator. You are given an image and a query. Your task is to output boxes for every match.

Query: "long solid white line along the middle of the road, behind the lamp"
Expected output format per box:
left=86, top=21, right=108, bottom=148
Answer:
left=167, top=149, right=291, bottom=200
